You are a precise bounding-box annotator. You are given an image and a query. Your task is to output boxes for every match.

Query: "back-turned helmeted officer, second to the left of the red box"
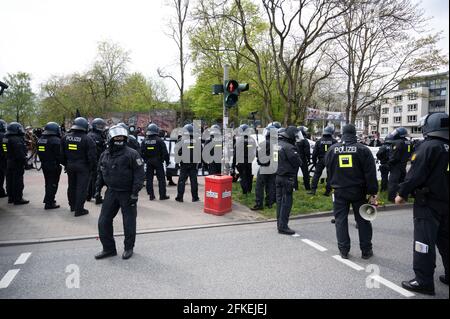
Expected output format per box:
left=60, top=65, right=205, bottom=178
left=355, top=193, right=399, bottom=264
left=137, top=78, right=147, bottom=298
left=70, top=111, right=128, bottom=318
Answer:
left=141, top=123, right=170, bottom=200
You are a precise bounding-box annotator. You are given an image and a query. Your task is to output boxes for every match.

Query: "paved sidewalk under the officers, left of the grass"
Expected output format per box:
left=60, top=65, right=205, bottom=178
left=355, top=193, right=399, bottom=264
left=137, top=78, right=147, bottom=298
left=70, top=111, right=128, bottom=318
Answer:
left=0, top=170, right=265, bottom=244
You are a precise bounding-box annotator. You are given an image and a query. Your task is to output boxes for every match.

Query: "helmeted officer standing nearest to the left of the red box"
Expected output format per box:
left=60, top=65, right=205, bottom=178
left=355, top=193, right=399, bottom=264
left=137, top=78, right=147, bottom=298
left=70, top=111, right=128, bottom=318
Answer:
left=175, top=124, right=201, bottom=202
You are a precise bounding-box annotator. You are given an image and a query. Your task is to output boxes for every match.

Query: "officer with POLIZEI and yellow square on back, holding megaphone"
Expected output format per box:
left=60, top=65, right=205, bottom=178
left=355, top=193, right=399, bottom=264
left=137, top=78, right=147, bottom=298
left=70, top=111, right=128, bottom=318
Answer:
left=325, top=124, right=378, bottom=259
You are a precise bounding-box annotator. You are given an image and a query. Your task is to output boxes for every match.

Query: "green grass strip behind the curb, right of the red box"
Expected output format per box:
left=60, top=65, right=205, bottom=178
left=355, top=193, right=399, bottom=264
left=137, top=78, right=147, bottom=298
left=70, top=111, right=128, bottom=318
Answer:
left=233, top=178, right=411, bottom=218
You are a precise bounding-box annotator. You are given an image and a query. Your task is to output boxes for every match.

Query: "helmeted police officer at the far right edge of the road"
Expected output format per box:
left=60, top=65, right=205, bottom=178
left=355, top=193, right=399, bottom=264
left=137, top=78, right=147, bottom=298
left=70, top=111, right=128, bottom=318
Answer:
left=395, top=113, right=449, bottom=295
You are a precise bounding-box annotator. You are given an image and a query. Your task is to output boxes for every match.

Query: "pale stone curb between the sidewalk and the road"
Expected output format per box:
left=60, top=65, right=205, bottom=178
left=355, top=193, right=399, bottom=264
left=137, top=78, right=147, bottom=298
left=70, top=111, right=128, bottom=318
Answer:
left=0, top=204, right=413, bottom=247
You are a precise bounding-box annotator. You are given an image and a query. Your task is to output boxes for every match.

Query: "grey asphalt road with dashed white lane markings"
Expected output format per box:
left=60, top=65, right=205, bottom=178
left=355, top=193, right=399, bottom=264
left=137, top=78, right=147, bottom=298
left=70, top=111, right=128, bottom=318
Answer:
left=0, top=210, right=449, bottom=299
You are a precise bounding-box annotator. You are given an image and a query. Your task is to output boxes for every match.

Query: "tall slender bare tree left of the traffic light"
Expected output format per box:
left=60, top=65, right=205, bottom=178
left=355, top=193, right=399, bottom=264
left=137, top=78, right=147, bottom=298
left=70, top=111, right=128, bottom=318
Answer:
left=157, top=0, right=190, bottom=123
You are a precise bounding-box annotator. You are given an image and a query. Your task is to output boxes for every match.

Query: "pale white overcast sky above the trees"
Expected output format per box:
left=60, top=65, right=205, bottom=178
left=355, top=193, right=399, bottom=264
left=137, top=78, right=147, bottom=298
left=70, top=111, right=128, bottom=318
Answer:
left=0, top=0, right=449, bottom=99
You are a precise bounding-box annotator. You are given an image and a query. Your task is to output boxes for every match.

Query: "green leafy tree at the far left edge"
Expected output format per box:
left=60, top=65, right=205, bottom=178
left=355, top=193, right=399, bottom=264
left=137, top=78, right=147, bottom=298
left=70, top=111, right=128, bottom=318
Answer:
left=2, top=72, right=36, bottom=124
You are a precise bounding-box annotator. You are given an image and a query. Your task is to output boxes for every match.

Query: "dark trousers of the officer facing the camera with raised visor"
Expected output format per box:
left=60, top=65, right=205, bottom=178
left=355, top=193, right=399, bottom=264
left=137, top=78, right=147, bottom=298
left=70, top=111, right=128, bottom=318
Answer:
left=98, top=188, right=137, bottom=252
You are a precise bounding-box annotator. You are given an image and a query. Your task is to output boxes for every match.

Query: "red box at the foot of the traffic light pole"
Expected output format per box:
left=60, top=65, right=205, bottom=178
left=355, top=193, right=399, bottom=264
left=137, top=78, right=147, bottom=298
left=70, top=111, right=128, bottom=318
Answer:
left=204, top=175, right=233, bottom=216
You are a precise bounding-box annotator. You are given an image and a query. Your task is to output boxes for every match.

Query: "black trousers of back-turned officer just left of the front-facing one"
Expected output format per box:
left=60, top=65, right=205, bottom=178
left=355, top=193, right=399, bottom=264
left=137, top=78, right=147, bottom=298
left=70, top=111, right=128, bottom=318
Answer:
left=67, top=168, right=89, bottom=213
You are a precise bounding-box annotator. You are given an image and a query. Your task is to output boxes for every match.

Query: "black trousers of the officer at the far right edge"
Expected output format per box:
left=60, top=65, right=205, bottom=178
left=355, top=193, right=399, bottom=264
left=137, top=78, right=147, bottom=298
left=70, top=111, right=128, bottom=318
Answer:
left=413, top=203, right=449, bottom=287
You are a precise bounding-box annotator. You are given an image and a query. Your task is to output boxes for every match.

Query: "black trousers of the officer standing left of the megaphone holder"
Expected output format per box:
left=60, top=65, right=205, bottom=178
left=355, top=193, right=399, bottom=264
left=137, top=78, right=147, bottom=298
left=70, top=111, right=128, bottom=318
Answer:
left=275, top=175, right=294, bottom=229
